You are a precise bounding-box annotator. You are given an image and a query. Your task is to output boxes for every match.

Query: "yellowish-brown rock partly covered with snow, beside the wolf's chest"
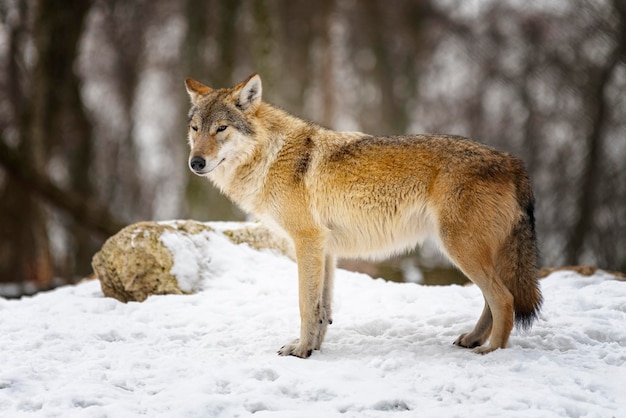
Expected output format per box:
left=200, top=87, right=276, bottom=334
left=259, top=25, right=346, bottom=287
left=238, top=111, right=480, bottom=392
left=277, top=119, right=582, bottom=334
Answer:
left=91, top=221, right=293, bottom=302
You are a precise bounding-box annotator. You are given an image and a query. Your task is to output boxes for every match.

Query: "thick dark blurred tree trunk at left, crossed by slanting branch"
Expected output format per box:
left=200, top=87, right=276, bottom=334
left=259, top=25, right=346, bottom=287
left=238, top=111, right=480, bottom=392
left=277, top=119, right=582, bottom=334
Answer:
left=31, top=0, right=97, bottom=277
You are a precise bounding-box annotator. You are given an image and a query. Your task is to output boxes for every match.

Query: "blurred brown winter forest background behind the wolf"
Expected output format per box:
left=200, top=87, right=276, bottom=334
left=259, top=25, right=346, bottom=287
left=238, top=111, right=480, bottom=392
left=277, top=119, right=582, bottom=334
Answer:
left=0, top=0, right=626, bottom=294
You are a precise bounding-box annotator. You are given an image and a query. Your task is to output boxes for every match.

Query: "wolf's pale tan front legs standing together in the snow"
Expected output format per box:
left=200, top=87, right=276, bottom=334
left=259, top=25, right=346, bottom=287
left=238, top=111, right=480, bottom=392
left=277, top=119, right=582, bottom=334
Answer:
left=278, top=234, right=334, bottom=358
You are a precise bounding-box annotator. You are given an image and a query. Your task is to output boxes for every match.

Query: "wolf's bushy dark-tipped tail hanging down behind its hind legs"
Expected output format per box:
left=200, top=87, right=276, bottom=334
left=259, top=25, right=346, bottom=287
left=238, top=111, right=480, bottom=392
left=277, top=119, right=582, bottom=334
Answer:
left=497, top=171, right=543, bottom=329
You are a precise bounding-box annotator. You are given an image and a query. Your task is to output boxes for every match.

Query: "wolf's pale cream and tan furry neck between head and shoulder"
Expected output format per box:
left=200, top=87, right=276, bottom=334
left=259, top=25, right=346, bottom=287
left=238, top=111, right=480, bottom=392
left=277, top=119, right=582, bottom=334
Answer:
left=210, top=103, right=310, bottom=216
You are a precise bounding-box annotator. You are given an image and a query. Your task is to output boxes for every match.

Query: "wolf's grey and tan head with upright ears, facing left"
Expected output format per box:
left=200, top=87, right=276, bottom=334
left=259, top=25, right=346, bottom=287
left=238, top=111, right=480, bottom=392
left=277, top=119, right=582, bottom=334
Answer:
left=185, top=74, right=262, bottom=176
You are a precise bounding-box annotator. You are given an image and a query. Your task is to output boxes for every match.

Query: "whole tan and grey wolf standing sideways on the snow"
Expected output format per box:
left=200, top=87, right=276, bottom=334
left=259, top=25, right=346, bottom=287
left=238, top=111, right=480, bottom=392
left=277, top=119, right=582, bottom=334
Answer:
left=186, top=75, right=541, bottom=357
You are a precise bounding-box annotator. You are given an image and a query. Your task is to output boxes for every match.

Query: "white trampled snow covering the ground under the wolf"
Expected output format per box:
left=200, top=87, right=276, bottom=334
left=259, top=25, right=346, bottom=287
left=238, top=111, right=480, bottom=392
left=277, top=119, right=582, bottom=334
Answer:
left=0, top=229, right=626, bottom=417
